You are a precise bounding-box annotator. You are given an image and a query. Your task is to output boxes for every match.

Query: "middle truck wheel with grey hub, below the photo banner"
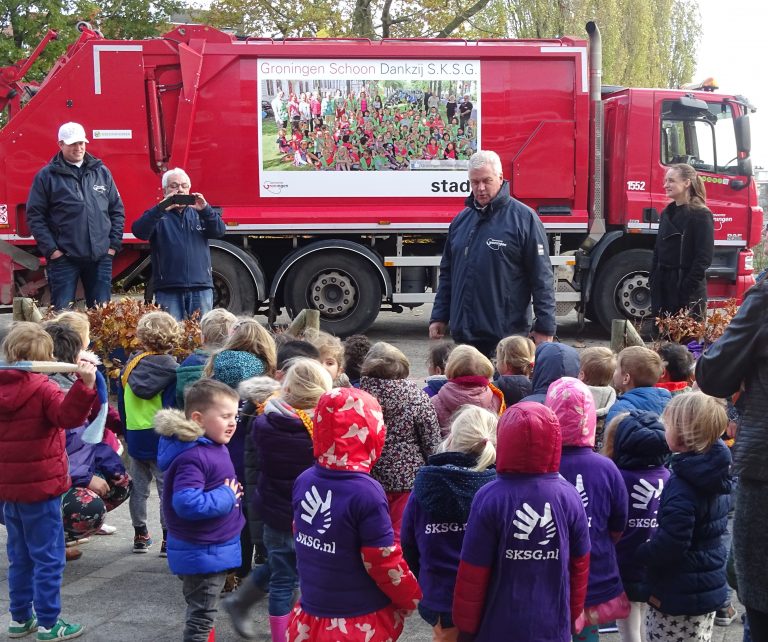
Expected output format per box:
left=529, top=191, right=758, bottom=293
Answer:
left=284, top=252, right=381, bottom=337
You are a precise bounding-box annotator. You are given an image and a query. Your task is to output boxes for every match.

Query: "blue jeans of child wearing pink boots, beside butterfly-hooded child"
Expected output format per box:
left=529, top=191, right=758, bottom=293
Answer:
left=253, top=524, right=299, bottom=615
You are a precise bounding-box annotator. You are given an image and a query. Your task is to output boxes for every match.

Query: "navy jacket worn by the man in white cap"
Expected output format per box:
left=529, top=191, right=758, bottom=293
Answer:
left=27, top=152, right=125, bottom=261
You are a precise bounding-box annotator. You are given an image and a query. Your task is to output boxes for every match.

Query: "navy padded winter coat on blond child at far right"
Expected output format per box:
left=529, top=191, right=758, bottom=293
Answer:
left=637, top=440, right=732, bottom=615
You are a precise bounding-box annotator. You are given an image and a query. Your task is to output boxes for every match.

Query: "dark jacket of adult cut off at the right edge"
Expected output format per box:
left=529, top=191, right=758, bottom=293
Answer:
left=696, top=279, right=768, bottom=483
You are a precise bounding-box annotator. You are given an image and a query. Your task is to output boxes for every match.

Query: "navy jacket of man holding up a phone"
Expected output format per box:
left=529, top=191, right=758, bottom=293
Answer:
left=131, top=206, right=226, bottom=290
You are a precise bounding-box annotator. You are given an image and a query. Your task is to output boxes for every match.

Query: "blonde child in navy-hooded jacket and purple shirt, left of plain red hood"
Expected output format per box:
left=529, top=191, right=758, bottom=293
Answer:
left=400, top=406, right=498, bottom=640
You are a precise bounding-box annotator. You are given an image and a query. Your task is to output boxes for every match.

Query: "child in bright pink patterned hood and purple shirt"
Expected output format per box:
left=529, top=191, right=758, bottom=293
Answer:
left=544, top=377, right=629, bottom=641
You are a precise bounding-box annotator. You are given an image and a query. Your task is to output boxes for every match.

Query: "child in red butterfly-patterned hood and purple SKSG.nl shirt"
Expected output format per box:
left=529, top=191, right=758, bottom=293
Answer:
left=285, top=388, right=421, bottom=642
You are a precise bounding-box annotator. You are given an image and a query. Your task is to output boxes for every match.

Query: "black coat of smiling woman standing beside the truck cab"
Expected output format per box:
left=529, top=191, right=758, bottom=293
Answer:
left=650, top=202, right=715, bottom=316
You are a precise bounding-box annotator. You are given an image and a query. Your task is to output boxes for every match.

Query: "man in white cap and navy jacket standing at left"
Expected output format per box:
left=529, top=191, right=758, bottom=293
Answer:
left=27, top=123, right=125, bottom=309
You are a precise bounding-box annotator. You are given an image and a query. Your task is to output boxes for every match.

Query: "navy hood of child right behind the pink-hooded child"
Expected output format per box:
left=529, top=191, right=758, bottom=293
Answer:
left=613, top=410, right=669, bottom=470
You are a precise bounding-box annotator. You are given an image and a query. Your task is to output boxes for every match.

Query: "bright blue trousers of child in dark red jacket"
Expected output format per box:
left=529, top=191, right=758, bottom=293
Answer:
left=5, top=497, right=66, bottom=628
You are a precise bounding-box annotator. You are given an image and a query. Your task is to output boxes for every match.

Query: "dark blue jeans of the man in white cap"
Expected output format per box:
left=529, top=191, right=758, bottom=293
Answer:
left=48, top=254, right=112, bottom=310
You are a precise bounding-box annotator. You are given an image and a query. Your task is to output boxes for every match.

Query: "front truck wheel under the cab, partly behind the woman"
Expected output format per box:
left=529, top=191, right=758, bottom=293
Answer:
left=591, top=249, right=653, bottom=332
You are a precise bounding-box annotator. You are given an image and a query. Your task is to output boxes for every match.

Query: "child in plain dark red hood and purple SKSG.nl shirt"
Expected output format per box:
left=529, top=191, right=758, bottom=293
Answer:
left=453, top=402, right=589, bottom=642
